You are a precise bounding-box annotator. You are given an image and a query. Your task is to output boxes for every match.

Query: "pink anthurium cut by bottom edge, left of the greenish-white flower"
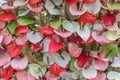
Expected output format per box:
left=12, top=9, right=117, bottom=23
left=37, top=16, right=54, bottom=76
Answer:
left=16, top=71, right=35, bottom=80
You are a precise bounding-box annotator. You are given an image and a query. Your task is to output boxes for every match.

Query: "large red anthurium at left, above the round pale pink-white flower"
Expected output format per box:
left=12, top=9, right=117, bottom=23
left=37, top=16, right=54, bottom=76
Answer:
left=7, top=44, right=22, bottom=57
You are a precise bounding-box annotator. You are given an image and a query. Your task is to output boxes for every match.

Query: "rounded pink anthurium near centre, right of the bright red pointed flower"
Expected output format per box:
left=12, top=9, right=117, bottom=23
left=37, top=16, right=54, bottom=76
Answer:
left=68, top=43, right=82, bottom=57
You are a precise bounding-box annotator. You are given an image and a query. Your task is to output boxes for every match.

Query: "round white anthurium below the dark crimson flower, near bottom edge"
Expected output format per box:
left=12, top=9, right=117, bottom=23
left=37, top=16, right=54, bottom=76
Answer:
left=82, top=66, right=97, bottom=79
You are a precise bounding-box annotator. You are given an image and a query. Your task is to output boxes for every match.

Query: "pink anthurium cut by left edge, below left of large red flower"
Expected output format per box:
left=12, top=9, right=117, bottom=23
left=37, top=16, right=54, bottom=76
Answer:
left=0, top=54, right=11, bottom=66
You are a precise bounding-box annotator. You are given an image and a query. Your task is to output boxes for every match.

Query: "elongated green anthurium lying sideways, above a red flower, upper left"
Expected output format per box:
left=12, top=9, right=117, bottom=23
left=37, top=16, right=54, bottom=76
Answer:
left=17, top=17, right=35, bottom=26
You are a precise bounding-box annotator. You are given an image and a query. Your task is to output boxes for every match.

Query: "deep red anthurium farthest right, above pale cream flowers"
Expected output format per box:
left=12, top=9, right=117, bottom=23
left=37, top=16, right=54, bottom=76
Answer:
left=102, top=15, right=115, bottom=26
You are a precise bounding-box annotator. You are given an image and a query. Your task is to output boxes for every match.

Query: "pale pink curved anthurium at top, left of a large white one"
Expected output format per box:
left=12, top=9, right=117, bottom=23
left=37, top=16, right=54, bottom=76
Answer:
left=69, top=4, right=86, bottom=15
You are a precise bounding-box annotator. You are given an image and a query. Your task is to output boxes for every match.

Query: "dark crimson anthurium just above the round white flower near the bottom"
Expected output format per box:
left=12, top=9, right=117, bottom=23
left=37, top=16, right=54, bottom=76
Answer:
left=78, top=53, right=91, bottom=67
